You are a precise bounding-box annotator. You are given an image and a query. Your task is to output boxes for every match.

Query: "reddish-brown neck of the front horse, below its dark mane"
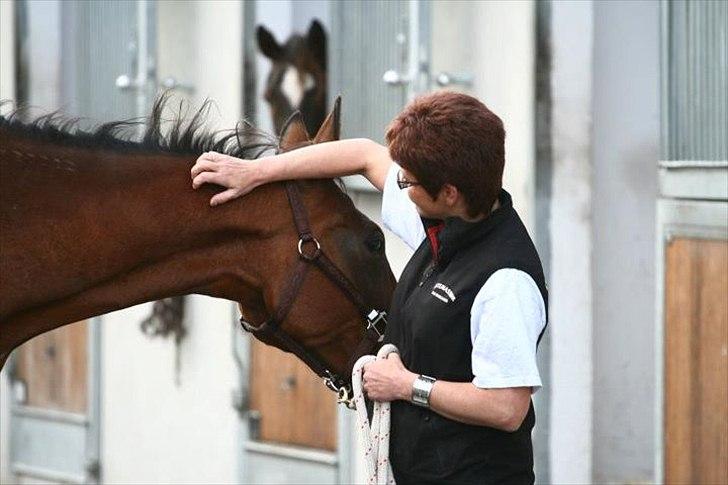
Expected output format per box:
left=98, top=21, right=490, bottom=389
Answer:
left=0, top=134, right=290, bottom=350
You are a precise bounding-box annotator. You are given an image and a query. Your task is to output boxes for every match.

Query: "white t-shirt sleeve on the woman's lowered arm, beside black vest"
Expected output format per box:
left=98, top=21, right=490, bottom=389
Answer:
left=470, top=268, right=546, bottom=393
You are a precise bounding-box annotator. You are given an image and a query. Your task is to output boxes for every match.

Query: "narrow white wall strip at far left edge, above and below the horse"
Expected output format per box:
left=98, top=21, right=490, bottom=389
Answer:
left=0, top=1, right=15, bottom=483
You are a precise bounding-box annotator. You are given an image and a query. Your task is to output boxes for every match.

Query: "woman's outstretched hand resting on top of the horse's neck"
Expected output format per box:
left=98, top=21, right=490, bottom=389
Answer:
left=190, top=152, right=259, bottom=206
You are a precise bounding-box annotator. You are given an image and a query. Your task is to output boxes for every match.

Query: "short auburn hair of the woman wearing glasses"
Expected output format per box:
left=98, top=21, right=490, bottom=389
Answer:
left=386, top=91, right=506, bottom=217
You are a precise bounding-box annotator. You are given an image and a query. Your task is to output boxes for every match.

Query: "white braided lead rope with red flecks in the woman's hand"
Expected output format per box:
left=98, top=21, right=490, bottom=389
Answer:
left=351, top=344, right=399, bottom=485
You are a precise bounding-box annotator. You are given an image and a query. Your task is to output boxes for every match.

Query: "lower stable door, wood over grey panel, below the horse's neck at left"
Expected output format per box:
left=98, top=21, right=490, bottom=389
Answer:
left=10, top=321, right=100, bottom=483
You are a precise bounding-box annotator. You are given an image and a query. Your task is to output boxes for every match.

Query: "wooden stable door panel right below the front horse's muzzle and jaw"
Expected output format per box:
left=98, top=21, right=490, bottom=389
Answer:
left=250, top=339, right=337, bottom=451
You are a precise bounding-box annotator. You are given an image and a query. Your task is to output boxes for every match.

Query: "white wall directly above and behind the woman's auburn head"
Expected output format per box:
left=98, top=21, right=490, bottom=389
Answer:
left=430, top=0, right=536, bottom=235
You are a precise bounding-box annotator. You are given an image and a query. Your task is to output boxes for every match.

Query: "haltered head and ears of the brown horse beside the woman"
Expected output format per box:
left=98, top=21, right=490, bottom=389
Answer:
left=232, top=98, right=395, bottom=388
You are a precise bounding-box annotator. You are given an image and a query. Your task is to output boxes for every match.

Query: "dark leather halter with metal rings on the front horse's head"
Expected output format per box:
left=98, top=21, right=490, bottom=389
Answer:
left=240, top=181, right=387, bottom=407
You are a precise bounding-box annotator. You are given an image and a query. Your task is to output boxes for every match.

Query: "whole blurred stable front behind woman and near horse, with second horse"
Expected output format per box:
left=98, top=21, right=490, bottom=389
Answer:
left=0, top=0, right=728, bottom=483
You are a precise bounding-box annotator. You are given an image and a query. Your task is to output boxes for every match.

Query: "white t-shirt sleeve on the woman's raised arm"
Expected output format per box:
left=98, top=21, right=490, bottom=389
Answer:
left=382, top=163, right=425, bottom=250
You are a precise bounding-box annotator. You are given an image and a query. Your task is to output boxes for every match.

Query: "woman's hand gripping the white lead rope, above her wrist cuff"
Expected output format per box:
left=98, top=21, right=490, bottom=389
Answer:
left=363, top=353, right=417, bottom=401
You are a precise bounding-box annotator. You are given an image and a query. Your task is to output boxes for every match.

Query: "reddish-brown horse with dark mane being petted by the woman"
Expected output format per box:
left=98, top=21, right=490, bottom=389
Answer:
left=0, top=98, right=395, bottom=392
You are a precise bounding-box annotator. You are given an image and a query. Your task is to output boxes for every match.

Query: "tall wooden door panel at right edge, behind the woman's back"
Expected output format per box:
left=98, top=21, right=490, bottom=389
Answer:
left=664, top=238, right=728, bottom=484
